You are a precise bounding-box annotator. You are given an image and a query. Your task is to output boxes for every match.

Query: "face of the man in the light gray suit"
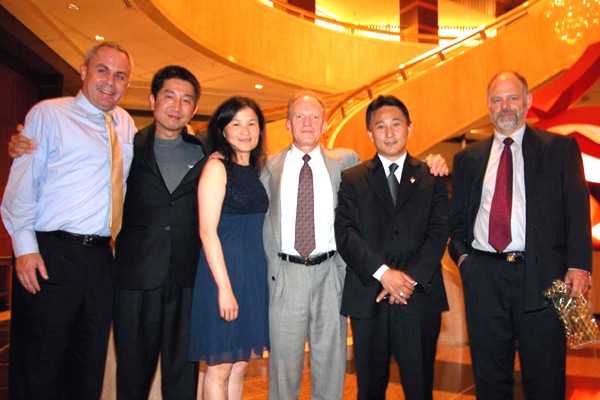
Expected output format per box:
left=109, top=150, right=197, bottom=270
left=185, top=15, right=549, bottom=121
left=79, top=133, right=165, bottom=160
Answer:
left=285, top=96, right=327, bottom=153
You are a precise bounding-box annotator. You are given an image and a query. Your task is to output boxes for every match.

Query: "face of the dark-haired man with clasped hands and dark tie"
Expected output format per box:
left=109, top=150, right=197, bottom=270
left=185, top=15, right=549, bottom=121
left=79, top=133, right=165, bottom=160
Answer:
left=368, top=106, right=412, bottom=161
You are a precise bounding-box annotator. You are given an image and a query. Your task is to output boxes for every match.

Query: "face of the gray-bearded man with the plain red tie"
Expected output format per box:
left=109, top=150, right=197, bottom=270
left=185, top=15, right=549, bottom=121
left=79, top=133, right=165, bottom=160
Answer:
left=488, top=73, right=533, bottom=136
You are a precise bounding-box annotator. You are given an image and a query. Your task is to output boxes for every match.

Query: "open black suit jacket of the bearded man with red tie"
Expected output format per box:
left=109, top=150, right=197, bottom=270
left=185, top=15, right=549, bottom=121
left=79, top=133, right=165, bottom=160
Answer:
left=448, top=127, right=592, bottom=311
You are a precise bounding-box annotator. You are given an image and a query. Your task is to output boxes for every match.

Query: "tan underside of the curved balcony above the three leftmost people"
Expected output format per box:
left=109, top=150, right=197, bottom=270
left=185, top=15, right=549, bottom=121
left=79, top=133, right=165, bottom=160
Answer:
left=1, top=0, right=310, bottom=115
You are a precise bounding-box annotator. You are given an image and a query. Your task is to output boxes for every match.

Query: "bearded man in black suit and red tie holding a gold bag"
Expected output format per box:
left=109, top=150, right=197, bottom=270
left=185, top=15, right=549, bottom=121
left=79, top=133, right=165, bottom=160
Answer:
left=449, top=72, right=592, bottom=400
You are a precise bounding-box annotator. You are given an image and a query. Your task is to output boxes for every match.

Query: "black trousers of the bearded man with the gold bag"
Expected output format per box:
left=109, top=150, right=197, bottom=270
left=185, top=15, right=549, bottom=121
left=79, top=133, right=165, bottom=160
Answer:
left=461, top=252, right=566, bottom=400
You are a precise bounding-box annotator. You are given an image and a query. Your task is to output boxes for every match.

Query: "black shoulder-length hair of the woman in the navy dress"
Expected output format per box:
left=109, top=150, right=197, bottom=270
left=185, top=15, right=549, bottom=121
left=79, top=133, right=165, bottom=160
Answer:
left=208, top=96, right=265, bottom=171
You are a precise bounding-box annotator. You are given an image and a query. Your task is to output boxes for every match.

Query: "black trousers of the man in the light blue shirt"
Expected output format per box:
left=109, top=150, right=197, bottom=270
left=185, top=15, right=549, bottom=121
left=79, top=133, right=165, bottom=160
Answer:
left=9, top=233, right=114, bottom=400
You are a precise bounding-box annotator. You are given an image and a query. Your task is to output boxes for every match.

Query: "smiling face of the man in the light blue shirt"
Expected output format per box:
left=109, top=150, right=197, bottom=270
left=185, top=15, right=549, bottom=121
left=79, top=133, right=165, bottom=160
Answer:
left=81, top=46, right=131, bottom=111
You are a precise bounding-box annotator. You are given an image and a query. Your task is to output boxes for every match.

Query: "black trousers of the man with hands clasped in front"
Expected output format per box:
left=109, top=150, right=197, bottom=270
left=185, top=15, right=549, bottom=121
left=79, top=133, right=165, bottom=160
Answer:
left=350, top=306, right=441, bottom=400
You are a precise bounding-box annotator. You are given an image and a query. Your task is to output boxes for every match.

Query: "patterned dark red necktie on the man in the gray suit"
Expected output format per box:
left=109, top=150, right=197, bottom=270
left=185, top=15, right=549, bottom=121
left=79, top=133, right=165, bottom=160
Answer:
left=294, top=154, right=316, bottom=258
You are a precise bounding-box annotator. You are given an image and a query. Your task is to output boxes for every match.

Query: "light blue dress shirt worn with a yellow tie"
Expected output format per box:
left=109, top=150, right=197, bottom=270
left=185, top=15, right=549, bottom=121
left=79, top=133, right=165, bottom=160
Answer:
left=1, top=92, right=136, bottom=257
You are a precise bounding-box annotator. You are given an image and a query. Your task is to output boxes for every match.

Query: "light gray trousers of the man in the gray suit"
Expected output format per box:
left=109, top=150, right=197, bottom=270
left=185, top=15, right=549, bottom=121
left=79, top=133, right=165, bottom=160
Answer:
left=269, top=258, right=347, bottom=400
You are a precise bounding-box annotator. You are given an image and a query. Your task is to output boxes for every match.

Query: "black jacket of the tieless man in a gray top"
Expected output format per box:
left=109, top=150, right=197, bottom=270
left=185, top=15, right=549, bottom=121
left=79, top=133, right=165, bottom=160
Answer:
left=115, top=124, right=204, bottom=290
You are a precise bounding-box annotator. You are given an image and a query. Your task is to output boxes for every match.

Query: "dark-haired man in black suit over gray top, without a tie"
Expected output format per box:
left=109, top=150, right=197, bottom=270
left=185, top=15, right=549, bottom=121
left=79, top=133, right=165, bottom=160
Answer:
left=114, top=66, right=204, bottom=400
